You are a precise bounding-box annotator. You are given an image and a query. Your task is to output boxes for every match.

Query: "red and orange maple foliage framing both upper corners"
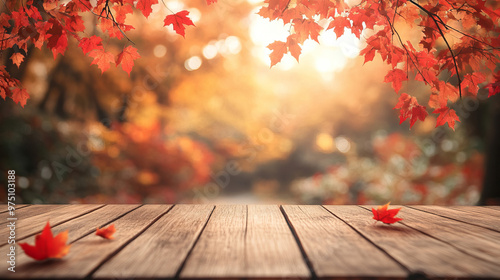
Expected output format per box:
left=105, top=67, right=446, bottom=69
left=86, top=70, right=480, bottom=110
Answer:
left=0, top=0, right=500, bottom=129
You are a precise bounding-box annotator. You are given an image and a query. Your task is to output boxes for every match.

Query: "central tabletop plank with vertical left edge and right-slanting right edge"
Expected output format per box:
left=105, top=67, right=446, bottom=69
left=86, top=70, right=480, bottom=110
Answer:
left=245, top=205, right=311, bottom=278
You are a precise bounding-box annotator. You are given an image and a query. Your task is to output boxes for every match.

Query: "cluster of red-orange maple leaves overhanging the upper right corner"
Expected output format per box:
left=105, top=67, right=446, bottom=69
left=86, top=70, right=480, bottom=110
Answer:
left=259, top=0, right=500, bottom=129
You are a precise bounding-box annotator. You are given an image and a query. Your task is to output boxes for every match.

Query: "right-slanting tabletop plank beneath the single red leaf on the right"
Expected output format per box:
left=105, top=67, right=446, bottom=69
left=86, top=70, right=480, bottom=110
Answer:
left=325, top=206, right=500, bottom=278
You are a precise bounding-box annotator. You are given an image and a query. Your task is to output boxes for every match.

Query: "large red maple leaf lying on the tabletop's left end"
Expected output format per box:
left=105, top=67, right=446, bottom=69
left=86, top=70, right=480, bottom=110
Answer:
left=19, top=222, right=71, bottom=261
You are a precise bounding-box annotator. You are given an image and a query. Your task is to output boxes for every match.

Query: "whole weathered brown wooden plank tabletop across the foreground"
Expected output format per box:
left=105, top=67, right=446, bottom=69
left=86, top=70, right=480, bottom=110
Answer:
left=0, top=204, right=500, bottom=279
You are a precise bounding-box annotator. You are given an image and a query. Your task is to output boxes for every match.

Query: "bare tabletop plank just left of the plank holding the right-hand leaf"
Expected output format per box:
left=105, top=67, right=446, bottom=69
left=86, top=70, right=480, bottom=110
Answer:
left=283, top=205, right=408, bottom=278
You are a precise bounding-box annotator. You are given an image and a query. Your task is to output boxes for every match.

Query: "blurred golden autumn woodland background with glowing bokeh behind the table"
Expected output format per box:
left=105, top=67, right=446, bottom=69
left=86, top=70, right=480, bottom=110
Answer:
left=0, top=0, right=500, bottom=205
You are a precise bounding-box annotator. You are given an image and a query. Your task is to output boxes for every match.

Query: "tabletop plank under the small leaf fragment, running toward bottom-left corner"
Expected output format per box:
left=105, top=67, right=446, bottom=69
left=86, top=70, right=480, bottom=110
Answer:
left=0, top=205, right=171, bottom=279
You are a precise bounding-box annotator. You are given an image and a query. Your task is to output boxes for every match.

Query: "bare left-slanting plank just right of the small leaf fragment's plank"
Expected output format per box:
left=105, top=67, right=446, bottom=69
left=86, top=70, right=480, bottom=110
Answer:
left=93, top=205, right=214, bottom=279
